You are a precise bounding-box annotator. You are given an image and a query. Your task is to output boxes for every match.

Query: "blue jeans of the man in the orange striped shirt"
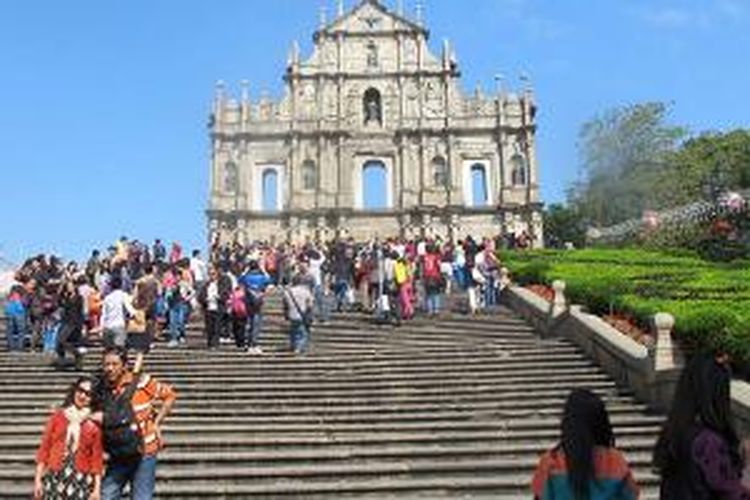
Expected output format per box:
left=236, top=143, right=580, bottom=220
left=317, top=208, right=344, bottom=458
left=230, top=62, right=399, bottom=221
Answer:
left=102, top=456, right=157, bottom=500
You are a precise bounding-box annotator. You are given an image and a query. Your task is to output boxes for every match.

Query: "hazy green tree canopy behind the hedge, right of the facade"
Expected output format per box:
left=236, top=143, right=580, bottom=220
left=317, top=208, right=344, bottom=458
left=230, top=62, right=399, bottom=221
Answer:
left=568, top=102, right=750, bottom=227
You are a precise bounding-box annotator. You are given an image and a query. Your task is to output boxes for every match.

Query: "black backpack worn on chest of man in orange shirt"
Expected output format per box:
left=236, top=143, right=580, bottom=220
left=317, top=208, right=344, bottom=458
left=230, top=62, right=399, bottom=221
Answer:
left=103, top=380, right=143, bottom=462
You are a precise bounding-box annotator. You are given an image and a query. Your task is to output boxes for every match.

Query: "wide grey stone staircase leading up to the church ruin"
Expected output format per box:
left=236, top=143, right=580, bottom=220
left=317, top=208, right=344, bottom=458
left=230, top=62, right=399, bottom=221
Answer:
left=0, top=300, right=663, bottom=499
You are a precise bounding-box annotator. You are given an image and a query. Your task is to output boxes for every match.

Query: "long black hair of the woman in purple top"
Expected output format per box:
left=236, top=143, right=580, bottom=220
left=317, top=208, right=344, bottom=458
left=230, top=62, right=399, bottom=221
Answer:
left=654, top=353, right=742, bottom=476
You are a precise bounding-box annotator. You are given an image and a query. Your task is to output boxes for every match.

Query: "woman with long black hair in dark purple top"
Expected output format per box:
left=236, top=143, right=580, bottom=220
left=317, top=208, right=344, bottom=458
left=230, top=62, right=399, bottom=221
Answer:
left=654, top=354, right=750, bottom=500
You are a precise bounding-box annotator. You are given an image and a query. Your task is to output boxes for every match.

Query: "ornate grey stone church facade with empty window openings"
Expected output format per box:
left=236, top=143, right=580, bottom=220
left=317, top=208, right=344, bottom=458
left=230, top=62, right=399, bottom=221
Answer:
left=207, top=0, right=543, bottom=246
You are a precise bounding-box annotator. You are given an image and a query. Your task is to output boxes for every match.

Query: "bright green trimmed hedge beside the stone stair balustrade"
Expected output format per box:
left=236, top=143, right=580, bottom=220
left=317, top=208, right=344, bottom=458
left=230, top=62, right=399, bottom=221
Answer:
left=500, top=249, right=750, bottom=367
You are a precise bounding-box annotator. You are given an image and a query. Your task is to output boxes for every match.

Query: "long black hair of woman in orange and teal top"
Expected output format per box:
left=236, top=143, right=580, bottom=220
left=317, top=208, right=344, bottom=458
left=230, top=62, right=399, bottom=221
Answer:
left=560, top=389, right=615, bottom=499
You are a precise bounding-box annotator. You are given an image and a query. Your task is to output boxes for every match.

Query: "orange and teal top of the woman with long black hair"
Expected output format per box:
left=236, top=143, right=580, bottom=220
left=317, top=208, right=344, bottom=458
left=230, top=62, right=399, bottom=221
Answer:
left=531, top=447, right=640, bottom=500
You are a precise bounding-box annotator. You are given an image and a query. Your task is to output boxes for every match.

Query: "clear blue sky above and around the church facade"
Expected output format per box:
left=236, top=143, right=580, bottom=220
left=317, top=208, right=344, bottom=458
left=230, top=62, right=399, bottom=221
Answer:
left=0, top=0, right=750, bottom=261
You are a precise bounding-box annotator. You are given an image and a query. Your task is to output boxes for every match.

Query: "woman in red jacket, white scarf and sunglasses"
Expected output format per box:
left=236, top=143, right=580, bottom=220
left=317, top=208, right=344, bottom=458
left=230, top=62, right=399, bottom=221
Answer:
left=34, top=377, right=104, bottom=500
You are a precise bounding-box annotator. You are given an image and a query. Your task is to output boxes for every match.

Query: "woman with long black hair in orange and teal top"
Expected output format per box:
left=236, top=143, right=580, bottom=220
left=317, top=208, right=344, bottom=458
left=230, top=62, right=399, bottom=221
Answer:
left=531, top=389, right=639, bottom=500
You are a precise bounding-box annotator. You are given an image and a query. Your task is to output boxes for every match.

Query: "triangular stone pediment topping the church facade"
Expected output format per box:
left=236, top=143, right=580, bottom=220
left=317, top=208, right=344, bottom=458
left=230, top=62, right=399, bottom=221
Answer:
left=322, top=0, right=427, bottom=35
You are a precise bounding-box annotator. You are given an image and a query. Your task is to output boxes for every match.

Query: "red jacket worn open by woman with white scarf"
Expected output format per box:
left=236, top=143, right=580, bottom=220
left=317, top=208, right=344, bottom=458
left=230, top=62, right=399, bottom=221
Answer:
left=36, top=409, right=104, bottom=475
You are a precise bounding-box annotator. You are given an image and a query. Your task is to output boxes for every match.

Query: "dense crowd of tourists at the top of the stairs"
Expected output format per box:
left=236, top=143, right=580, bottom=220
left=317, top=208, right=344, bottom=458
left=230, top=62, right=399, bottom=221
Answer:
left=5, top=233, right=516, bottom=360
